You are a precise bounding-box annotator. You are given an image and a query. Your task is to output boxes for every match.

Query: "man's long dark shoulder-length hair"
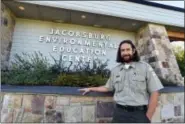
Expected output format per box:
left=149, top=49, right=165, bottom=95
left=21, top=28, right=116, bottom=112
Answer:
left=116, top=40, right=140, bottom=63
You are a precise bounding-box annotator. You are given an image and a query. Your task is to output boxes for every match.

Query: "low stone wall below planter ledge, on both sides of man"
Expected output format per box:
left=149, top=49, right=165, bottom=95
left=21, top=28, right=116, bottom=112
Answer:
left=0, top=92, right=184, bottom=123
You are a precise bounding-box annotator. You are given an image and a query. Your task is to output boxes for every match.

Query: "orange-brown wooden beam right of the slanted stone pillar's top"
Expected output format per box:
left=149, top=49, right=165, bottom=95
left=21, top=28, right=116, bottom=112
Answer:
left=167, top=31, right=185, bottom=41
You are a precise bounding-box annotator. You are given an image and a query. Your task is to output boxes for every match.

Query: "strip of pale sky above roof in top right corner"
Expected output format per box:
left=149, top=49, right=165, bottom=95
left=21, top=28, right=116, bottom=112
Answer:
left=151, top=0, right=184, bottom=8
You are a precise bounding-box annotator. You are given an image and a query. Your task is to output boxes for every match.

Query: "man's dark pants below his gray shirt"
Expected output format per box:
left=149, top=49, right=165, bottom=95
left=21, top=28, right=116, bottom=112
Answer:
left=112, top=106, right=150, bottom=123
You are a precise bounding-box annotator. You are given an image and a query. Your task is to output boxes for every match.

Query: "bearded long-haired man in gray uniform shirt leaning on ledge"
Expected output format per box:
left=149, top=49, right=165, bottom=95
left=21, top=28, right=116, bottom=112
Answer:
left=80, top=40, right=163, bottom=123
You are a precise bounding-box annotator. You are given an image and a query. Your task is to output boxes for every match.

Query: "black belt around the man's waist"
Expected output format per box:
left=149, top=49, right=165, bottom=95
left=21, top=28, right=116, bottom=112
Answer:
left=116, top=104, right=147, bottom=111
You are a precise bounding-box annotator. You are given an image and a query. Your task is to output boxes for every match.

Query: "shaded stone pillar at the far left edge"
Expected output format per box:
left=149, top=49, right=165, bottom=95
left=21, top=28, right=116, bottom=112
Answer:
left=1, top=3, right=15, bottom=69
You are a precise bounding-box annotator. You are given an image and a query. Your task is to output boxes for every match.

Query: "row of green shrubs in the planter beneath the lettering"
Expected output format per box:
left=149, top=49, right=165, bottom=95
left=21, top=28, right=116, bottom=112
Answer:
left=1, top=52, right=110, bottom=87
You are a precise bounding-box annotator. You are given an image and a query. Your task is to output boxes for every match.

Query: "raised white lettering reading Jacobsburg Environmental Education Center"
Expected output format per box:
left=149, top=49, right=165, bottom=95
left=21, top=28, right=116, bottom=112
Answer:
left=39, top=29, right=118, bottom=62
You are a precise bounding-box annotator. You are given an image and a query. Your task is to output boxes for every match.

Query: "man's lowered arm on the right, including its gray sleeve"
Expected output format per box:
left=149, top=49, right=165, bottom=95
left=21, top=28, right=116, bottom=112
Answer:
left=146, top=64, right=163, bottom=120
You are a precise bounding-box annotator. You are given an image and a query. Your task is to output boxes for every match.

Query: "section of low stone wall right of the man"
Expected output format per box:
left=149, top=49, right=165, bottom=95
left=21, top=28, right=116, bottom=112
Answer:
left=158, top=92, right=184, bottom=123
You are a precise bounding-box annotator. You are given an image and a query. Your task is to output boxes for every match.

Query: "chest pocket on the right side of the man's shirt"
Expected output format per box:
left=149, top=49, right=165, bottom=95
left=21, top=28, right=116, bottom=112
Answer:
left=131, top=75, right=146, bottom=90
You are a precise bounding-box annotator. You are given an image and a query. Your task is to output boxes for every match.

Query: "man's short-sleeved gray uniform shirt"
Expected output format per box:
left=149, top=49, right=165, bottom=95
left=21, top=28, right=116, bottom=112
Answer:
left=105, top=61, right=163, bottom=106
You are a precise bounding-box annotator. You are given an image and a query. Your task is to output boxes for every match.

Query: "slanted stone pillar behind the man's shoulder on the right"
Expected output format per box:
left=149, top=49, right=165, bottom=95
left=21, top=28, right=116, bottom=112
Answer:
left=136, top=24, right=184, bottom=86
